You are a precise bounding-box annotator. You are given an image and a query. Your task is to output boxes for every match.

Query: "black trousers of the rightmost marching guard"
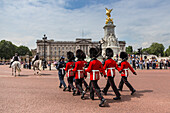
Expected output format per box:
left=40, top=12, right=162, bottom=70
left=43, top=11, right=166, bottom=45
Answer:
left=119, top=76, right=134, bottom=91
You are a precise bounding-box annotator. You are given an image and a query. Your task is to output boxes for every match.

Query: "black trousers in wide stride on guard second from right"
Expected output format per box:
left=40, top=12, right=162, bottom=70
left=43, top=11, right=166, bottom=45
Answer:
left=103, top=76, right=120, bottom=97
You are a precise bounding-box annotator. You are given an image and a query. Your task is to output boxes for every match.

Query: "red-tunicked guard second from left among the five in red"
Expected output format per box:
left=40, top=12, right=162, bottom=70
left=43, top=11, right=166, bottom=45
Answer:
left=72, top=49, right=85, bottom=99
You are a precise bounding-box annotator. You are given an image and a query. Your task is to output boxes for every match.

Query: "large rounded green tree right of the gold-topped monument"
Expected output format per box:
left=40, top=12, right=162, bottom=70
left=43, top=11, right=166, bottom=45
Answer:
left=149, top=43, right=165, bottom=56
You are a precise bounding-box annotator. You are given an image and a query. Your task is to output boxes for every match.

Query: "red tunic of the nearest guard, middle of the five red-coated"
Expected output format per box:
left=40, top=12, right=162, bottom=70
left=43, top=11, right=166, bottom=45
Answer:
left=85, top=60, right=106, bottom=80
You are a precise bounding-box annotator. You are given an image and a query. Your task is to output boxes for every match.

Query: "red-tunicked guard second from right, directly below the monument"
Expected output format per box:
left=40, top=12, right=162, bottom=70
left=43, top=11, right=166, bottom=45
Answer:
left=102, top=48, right=121, bottom=100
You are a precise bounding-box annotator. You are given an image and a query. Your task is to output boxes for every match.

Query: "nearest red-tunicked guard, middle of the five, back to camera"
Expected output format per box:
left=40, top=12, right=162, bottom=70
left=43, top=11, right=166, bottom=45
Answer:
left=85, top=48, right=106, bottom=107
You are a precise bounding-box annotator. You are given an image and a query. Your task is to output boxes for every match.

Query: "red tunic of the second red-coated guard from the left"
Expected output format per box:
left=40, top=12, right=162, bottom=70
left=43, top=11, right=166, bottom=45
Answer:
left=72, top=61, right=85, bottom=79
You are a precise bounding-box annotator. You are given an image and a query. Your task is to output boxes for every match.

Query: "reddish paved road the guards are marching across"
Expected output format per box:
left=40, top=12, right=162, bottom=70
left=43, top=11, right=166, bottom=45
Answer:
left=0, top=66, right=170, bottom=113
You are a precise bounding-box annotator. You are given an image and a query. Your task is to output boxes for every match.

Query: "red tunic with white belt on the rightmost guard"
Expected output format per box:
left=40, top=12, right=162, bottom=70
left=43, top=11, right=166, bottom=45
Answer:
left=118, top=61, right=135, bottom=77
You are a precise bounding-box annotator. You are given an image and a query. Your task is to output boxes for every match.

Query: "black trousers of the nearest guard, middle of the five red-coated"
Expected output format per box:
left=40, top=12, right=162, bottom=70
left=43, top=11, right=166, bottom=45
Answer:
left=90, top=80, right=103, bottom=100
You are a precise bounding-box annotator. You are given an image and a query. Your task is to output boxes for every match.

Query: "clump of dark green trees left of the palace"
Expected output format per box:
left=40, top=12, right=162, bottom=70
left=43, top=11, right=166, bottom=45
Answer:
left=0, top=40, right=32, bottom=59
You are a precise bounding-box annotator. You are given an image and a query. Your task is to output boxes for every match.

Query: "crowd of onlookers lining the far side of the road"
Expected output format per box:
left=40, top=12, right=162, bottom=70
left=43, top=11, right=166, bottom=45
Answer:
left=0, top=56, right=170, bottom=70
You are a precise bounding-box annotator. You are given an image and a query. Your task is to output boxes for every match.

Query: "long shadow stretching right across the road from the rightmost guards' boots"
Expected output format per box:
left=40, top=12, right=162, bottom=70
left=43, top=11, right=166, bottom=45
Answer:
left=107, top=90, right=153, bottom=103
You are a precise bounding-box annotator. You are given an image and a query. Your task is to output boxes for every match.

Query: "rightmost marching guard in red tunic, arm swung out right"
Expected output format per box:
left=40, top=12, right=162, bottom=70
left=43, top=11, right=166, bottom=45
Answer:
left=119, top=52, right=137, bottom=95
